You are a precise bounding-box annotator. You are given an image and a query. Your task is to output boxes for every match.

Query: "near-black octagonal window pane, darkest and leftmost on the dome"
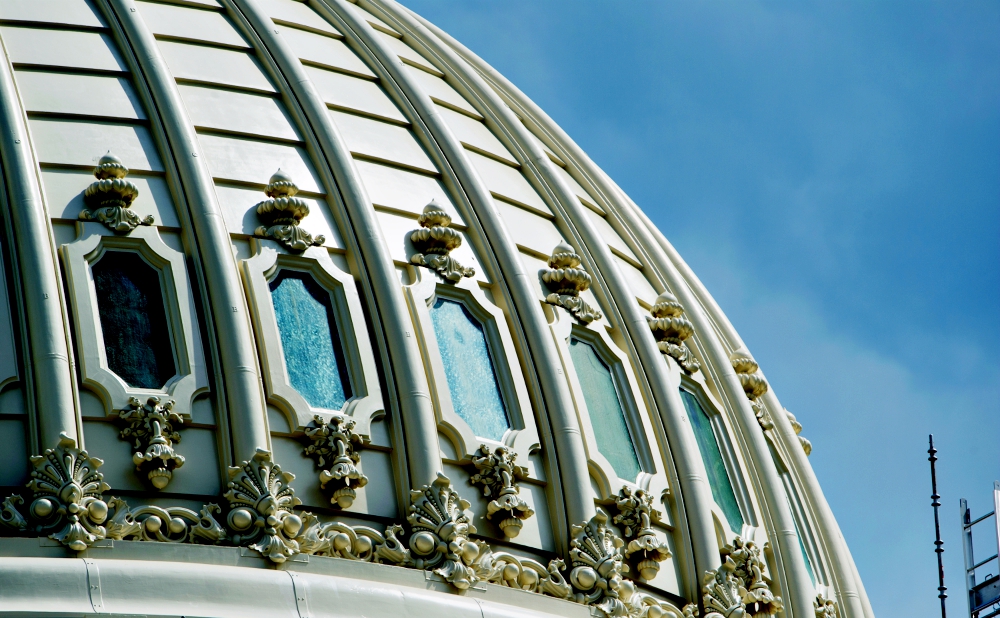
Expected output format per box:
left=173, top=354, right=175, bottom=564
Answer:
left=91, top=251, right=177, bottom=388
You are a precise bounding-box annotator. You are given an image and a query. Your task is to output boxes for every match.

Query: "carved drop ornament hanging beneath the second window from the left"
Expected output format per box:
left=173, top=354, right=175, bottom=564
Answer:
left=302, top=415, right=368, bottom=509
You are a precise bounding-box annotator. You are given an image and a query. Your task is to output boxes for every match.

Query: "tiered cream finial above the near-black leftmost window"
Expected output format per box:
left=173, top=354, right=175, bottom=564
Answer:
left=80, top=150, right=153, bottom=234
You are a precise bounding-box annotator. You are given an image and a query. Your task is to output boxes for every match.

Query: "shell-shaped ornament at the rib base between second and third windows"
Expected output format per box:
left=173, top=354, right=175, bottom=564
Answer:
left=406, top=472, right=491, bottom=590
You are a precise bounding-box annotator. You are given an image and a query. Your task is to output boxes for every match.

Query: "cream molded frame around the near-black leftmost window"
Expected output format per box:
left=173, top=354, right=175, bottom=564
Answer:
left=60, top=222, right=209, bottom=419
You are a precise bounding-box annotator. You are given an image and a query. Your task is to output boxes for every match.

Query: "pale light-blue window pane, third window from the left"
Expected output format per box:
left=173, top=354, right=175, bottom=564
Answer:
left=431, top=298, right=510, bottom=442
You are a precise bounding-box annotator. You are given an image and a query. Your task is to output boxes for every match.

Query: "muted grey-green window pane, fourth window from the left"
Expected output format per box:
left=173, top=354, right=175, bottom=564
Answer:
left=569, top=339, right=642, bottom=481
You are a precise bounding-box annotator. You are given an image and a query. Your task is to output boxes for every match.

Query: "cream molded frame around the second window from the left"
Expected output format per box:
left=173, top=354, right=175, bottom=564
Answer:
left=240, top=239, right=385, bottom=438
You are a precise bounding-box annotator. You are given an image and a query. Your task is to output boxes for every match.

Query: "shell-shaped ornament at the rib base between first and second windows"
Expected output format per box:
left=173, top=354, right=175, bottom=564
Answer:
left=226, top=449, right=302, bottom=563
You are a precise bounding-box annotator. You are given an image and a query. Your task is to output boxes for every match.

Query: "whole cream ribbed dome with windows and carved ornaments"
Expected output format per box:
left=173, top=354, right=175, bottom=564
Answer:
left=0, top=0, right=872, bottom=618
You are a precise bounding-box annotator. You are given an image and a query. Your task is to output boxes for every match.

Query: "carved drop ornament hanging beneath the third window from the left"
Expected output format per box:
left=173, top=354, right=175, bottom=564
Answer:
left=471, top=444, right=535, bottom=539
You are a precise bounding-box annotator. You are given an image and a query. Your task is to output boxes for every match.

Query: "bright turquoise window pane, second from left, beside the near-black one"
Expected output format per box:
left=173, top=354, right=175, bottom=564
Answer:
left=270, top=270, right=351, bottom=410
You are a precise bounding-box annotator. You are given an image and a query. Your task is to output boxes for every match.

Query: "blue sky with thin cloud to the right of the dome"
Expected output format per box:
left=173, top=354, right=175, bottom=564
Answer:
left=405, top=0, right=1000, bottom=617
